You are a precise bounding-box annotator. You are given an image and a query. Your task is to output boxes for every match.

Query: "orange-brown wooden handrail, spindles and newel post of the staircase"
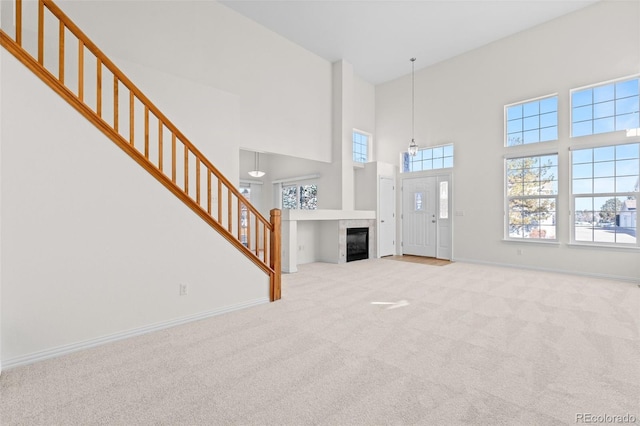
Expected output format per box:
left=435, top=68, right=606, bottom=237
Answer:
left=0, top=0, right=281, bottom=301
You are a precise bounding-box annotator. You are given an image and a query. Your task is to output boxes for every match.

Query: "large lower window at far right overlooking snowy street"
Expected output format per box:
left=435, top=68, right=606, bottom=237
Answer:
left=571, top=143, right=640, bottom=245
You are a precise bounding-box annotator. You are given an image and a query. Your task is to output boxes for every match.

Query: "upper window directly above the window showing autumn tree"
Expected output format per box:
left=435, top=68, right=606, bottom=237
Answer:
left=505, top=96, right=558, bottom=146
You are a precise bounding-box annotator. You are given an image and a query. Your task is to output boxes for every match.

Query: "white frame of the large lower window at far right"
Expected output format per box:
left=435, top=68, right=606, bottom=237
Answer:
left=569, top=140, right=640, bottom=248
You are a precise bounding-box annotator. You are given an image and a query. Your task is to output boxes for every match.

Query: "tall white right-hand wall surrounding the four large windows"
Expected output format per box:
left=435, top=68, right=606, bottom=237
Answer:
left=376, top=1, right=640, bottom=280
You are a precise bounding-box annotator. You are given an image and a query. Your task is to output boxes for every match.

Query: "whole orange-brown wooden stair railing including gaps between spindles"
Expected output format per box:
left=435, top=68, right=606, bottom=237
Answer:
left=0, top=0, right=281, bottom=301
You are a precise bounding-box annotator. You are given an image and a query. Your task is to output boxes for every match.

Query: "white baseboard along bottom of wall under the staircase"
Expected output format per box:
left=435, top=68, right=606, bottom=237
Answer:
left=2, top=297, right=269, bottom=371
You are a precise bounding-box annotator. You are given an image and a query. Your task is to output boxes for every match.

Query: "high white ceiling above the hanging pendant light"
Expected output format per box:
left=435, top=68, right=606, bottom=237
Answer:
left=220, top=0, right=598, bottom=84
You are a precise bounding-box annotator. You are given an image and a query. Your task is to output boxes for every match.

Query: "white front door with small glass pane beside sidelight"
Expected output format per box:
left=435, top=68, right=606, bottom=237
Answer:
left=402, top=176, right=438, bottom=257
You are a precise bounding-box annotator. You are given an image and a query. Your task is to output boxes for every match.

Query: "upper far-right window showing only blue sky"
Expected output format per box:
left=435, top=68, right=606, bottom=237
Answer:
left=571, top=78, right=640, bottom=137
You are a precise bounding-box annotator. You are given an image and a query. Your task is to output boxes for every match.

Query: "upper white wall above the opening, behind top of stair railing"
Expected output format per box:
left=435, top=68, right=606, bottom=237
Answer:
left=59, top=0, right=331, bottom=162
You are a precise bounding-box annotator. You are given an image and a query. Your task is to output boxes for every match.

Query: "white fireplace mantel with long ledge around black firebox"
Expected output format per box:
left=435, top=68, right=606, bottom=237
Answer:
left=282, top=209, right=376, bottom=273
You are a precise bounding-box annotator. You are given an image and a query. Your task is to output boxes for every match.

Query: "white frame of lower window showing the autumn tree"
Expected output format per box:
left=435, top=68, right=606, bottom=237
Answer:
left=503, top=151, right=560, bottom=244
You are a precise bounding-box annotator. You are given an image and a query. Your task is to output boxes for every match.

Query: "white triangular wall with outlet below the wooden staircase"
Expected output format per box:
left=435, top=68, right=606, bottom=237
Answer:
left=0, top=49, right=269, bottom=366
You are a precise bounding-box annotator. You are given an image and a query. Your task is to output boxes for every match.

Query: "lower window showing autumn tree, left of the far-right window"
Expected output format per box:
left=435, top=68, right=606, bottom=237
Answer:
left=506, top=154, right=558, bottom=240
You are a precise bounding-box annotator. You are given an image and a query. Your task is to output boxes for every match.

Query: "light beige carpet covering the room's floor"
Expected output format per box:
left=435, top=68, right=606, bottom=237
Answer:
left=0, top=259, right=640, bottom=425
